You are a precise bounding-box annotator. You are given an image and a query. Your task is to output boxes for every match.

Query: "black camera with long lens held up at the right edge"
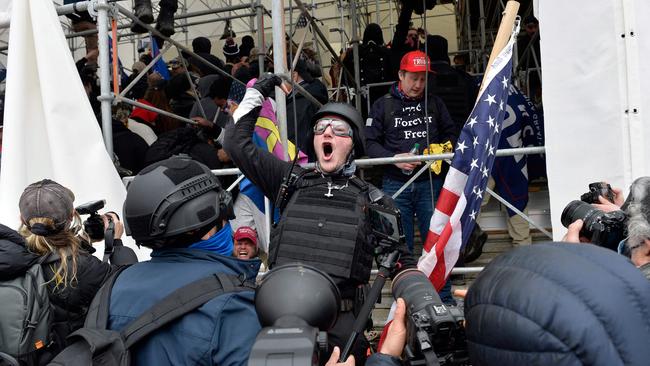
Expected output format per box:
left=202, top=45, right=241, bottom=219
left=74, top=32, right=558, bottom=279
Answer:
left=560, top=200, right=628, bottom=250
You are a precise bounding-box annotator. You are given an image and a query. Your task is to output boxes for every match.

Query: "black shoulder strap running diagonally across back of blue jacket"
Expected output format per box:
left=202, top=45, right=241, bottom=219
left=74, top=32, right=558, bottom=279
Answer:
left=122, top=273, right=254, bottom=348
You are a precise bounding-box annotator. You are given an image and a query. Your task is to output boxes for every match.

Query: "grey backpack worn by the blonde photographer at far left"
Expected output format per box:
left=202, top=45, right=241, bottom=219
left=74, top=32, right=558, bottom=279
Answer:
left=0, top=255, right=58, bottom=365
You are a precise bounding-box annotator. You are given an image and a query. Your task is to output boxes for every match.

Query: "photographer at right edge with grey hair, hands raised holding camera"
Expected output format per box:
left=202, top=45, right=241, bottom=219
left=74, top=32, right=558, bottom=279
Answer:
left=563, top=177, right=650, bottom=279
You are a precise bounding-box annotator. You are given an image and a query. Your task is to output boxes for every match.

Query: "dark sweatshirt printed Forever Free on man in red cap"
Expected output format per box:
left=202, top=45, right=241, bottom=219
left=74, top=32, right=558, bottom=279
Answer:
left=364, top=82, right=458, bottom=182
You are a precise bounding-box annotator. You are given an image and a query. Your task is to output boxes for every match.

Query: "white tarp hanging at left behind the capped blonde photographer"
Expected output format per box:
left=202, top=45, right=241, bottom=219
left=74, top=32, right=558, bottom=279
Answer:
left=0, top=0, right=149, bottom=259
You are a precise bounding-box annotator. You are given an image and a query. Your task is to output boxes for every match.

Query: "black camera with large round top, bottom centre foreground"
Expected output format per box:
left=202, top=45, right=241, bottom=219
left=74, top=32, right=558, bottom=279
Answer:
left=248, top=264, right=341, bottom=366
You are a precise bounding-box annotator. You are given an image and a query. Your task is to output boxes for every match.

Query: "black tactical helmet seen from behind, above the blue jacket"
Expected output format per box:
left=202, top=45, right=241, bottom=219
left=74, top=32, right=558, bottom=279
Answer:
left=124, top=155, right=233, bottom=248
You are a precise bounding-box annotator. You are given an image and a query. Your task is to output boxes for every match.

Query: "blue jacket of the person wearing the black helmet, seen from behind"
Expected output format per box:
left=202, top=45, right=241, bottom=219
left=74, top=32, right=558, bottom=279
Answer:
left=109, top=248, right=260, bottom=366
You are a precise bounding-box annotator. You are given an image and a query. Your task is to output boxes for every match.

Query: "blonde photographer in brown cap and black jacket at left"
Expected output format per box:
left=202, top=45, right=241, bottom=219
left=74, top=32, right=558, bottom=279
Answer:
left=0, top=179, right=124, bottom=362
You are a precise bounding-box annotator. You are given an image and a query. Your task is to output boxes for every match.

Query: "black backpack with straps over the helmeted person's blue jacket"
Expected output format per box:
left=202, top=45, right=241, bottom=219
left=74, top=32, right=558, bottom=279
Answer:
left=48, top=267, right=255, bottom=366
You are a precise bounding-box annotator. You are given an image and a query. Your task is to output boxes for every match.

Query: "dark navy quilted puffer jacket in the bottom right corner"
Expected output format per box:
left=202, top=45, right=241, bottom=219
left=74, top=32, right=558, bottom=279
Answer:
left=465, top=243, right=650, bottom=366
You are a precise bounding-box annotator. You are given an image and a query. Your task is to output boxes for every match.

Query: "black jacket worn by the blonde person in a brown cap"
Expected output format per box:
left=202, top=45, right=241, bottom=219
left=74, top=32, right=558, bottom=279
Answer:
left=0, top=224, right=113, bottom=348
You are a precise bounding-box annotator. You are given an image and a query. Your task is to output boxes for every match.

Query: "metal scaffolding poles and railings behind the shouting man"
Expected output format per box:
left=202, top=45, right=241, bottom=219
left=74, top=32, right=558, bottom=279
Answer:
left=0, top=0, right=550, bottom=246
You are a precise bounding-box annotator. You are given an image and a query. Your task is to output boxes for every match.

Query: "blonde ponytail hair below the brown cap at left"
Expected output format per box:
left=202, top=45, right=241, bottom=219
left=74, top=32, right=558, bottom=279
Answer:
left=18, top=212, right=83, bottom=290
